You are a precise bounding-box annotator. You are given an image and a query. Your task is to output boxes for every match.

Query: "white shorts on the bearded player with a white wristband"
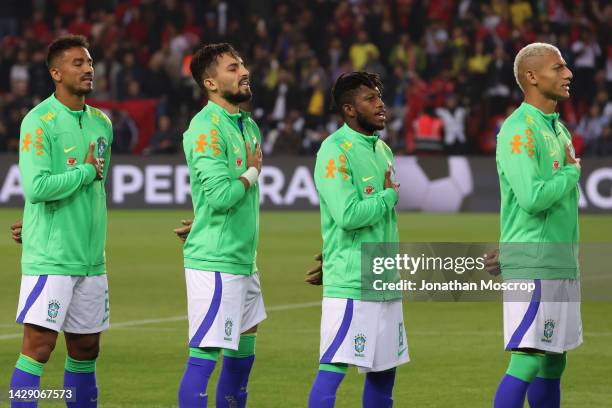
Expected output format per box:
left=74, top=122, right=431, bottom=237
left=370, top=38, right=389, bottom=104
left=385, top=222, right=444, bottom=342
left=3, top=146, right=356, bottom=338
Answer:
left=185, top=269, right=266, bottom=350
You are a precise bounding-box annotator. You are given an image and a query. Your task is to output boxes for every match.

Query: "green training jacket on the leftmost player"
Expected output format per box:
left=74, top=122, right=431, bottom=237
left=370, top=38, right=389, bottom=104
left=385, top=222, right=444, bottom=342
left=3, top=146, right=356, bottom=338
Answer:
left=19, top=95, right=113, bottom=276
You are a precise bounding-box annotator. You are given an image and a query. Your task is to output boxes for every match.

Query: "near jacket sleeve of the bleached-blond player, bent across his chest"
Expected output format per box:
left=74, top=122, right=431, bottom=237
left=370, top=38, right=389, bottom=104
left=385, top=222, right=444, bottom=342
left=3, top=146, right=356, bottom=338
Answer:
left=497, top=128, right=580, bottom=214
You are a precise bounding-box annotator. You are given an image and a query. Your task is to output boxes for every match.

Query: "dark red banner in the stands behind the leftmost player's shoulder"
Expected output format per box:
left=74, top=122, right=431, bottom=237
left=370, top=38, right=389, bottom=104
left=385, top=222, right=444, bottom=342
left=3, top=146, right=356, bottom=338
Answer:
left=87, top=99, right=158, bottom=154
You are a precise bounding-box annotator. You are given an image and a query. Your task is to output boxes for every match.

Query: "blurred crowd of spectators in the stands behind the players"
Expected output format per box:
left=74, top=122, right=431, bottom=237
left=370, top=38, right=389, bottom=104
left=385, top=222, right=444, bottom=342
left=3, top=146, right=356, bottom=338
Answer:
left=0, top=0, right=612, bottom=155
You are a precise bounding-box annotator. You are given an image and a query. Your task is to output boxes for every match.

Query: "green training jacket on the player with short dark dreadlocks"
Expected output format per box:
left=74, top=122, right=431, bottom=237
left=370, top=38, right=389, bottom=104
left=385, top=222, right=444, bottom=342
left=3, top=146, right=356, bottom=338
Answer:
left=314, top=124, right=401, bottom=300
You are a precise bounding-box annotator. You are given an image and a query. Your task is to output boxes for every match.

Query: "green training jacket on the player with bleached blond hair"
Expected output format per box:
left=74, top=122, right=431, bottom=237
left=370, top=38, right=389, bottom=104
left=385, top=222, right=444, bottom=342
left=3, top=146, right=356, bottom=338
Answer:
left=496, top=103, right=580, bottom=279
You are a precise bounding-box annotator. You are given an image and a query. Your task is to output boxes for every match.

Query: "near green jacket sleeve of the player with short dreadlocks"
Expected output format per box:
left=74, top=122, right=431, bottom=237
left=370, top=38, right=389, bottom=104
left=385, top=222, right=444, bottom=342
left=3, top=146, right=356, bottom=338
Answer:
left=315, top=144, right=397, bottom=231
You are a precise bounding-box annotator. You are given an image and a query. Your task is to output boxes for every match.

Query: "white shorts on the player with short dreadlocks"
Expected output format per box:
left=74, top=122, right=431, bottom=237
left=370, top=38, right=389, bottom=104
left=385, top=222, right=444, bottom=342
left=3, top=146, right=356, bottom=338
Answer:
left=320, top=298, right=410, bottom=372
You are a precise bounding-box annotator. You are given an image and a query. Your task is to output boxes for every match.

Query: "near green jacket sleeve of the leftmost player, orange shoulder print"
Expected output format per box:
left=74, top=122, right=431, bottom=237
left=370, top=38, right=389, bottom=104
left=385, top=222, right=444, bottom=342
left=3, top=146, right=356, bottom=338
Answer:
left=19, top=117, right=96, bottom=204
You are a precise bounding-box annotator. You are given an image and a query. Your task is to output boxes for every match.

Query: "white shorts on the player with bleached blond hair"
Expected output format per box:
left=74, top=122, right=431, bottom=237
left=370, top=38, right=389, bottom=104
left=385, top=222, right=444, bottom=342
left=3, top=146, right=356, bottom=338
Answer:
left=504, top=279, right=582, bottom=353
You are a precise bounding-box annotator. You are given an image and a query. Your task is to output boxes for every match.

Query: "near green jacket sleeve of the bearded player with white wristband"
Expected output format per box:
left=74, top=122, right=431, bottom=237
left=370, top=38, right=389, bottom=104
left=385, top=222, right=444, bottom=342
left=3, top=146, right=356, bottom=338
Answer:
left=191, top=125, right=246, bottom=211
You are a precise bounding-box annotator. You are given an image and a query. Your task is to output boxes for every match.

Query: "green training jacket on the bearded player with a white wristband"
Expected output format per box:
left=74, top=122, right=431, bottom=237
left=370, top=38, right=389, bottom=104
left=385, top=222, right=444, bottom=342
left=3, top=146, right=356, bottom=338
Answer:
left=183, top=101, right=261, bottom=275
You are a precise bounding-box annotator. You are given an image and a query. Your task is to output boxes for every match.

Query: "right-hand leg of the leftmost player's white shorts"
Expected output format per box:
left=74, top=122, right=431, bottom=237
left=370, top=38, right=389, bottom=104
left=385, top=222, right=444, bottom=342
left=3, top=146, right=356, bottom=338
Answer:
left=62, top=275, right=110, bottom=334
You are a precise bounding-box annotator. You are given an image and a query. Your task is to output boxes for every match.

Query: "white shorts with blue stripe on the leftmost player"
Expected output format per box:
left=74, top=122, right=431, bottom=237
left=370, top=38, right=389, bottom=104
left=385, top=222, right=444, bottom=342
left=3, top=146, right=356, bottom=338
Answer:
left=17, top=275, right=110, bottom=334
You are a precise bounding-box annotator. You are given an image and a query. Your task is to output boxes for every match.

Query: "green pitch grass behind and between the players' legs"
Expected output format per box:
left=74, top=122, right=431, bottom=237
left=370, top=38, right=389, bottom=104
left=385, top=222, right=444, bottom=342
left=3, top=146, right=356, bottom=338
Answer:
left=0, top=210, right=612, bottom=408
